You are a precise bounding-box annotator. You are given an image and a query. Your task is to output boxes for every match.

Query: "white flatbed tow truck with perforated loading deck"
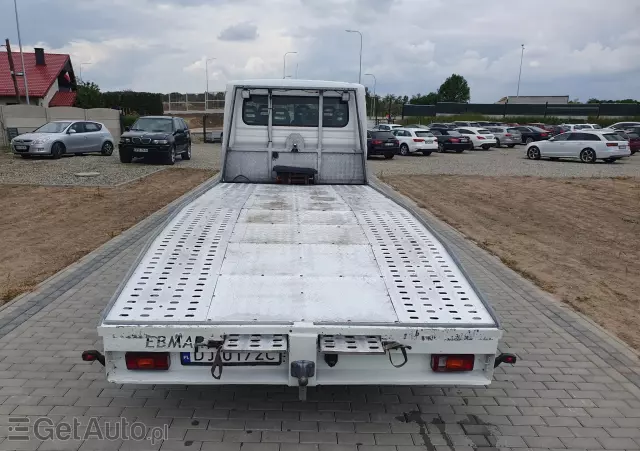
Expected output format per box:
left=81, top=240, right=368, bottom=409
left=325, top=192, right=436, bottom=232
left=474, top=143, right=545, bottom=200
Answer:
left=82, top=80, right=515, bottom=399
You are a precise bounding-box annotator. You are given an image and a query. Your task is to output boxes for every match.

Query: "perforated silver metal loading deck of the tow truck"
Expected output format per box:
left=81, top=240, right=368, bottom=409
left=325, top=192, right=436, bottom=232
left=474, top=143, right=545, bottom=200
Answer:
left=106, top=184, right=494, bottom=326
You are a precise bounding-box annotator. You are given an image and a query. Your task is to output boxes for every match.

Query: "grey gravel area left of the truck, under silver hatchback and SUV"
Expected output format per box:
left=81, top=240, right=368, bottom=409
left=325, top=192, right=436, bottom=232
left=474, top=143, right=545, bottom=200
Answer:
left=0, top=144, right=220, bottom=186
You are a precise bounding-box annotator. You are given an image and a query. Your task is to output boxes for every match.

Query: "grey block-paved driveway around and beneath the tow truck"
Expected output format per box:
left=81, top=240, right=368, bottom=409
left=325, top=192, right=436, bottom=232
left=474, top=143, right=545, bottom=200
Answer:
left=0, top=175, right=640, bottom=451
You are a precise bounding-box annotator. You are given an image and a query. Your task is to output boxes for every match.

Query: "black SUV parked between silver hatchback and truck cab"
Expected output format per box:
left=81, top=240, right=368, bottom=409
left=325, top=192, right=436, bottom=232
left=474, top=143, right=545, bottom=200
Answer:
left=118, top=116, right=191, bottom=164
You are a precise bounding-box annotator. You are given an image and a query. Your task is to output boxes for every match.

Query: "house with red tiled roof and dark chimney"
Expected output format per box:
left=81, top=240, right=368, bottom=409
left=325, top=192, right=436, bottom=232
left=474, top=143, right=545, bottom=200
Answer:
left=0, top=48, right=76, bottom=107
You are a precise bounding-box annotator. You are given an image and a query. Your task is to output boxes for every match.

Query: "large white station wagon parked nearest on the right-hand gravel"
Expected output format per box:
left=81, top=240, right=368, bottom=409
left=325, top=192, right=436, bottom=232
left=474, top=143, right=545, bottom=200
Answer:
left=526, top=130, right=631, bottom=163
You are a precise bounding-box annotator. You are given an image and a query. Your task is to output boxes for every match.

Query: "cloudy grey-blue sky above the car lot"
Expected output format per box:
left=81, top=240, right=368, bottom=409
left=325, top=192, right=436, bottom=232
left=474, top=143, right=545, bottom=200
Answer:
left=0, top=0, right=640, bottom=102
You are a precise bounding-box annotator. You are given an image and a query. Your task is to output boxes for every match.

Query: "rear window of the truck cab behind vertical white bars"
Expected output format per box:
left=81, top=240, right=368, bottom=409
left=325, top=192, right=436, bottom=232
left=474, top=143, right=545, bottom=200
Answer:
left=242, top=95, right=349, bottom=128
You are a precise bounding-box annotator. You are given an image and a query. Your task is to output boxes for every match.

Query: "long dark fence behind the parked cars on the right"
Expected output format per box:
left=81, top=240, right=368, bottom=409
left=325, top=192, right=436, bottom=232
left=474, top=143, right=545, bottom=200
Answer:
left=402, top=102, right=640, bottom=117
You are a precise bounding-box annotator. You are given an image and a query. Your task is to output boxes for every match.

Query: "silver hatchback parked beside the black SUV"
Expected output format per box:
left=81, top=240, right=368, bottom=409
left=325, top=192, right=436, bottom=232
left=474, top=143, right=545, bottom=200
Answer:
left=11, top=121, right=113, bottom=159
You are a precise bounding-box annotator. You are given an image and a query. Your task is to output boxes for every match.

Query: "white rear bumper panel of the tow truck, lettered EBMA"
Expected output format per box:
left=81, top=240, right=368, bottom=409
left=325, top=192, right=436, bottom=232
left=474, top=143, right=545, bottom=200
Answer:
left=98, top=323, right=502, bottom=386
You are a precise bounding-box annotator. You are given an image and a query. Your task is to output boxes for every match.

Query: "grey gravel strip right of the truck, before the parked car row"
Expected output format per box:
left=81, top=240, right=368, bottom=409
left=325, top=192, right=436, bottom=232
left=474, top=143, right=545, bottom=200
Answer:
left=369, top=146, right=640, bottom=178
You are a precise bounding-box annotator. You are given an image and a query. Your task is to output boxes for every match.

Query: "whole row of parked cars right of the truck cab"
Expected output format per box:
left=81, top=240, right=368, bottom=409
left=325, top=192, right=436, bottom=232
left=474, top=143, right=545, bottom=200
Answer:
left=367, top=121, right=640, bottom=162
